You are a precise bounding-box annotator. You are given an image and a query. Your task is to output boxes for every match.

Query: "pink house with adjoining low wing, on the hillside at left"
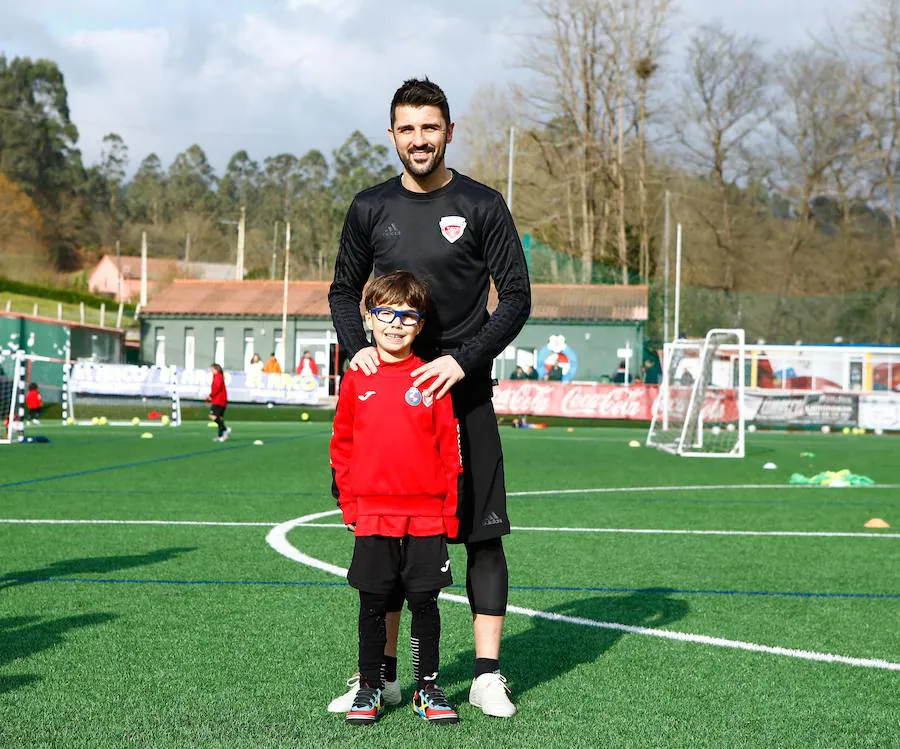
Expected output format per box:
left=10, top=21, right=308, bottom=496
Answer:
left=88, top=255, right=237, bottom=302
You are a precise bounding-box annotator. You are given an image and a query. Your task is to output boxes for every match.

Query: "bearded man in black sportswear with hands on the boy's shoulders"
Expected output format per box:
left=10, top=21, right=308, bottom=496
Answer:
left=329, top=79, right=531, bottom=717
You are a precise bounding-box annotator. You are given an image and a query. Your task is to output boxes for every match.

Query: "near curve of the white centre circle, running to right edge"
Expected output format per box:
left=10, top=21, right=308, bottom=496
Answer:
left=266, top=510, right=900, bottom=671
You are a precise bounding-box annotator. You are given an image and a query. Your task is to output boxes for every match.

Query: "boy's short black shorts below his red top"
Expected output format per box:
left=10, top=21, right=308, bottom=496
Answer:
left=347, top=536, right=453, bottom=595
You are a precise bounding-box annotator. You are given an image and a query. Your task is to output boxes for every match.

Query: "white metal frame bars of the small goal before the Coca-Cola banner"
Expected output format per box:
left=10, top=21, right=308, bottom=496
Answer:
left=646, top=328, right=746, bottom=458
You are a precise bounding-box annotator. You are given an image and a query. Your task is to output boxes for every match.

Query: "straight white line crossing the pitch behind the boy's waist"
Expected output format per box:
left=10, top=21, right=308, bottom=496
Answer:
left=0, top=510, right=900, bottom=539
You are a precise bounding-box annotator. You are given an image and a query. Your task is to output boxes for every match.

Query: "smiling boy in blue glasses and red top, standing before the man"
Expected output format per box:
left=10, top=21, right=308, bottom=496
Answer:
left=331, top=271, right=462, bottom=725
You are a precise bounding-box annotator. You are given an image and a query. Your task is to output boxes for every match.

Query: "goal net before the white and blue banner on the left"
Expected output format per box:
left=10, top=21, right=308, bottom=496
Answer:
left=62, top=362, right=181, bottom=427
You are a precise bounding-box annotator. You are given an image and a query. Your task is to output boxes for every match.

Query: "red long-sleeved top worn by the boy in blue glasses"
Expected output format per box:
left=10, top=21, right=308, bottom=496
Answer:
left=331, top=356, right=462, bottom=538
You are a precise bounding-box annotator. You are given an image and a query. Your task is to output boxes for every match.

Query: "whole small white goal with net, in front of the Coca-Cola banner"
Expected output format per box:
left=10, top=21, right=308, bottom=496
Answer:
left=647, top=328, right=745, bottom=458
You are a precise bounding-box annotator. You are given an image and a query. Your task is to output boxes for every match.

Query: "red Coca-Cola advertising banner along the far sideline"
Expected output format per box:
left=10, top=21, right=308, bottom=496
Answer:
left=494, top=380, right=738, bottom=423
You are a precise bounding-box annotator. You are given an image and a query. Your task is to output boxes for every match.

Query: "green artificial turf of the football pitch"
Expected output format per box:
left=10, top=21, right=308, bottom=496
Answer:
left=0, top=420, right=900, bottom=749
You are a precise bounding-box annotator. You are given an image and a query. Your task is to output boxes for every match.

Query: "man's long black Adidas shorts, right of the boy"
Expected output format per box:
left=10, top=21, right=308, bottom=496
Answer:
left=450, top=373, right=509, bottom=543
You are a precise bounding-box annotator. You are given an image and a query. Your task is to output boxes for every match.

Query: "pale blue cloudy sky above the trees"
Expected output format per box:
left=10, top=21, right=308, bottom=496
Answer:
left=0, top=0, right=859, bottom=174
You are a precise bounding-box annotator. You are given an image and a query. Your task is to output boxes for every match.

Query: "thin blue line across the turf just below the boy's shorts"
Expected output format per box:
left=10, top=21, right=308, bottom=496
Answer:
left=0, top=577, right=900, bottom=600
